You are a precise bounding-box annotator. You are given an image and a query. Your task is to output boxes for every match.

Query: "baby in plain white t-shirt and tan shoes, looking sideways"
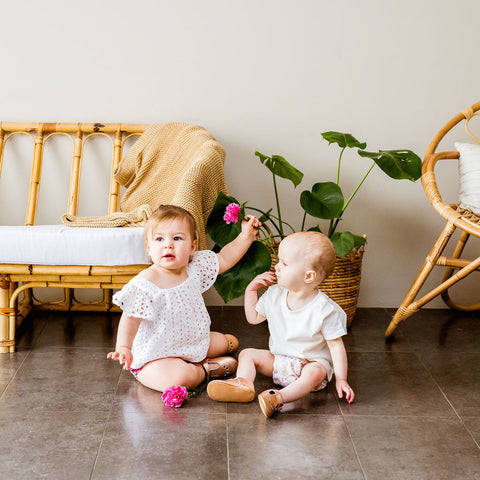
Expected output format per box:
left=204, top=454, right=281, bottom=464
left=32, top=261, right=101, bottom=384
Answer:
left=207, top=232, right=355, bottom=417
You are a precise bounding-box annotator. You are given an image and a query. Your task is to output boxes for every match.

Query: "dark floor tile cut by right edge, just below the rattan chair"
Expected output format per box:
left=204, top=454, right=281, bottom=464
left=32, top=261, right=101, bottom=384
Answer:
left=422, top=351, right=480, bottom=416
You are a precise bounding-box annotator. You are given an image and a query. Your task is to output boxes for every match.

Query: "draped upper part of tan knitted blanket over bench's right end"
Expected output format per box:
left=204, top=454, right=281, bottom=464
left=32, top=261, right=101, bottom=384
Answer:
left=114, top=122, right=227, bottom=249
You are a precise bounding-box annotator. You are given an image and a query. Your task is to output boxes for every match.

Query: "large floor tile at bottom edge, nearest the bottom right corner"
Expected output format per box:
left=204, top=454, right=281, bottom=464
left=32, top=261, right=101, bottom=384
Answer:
left=345, top=416, right=480, bottom=480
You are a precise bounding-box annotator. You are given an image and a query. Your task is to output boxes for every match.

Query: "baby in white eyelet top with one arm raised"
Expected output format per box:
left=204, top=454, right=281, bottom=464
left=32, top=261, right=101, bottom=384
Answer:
left=108, top=205, right=260, bottom=391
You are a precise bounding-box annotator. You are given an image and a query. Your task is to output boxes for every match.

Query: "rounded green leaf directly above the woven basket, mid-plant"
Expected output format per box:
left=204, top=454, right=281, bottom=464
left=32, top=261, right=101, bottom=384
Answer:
left=300, top=182, right=344, bottom=219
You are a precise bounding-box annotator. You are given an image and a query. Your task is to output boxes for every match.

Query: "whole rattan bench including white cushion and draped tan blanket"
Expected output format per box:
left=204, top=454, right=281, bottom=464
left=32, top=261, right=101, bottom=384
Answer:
left=0, top=122, right=226, bottom=353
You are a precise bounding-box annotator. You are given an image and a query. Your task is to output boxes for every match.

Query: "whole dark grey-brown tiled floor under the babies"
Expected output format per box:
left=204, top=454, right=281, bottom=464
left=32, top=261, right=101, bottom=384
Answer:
left=0, top=307, right=480, bottom=480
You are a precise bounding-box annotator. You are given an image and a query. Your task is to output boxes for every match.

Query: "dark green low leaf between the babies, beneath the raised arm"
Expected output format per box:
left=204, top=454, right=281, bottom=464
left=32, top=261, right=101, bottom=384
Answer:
left=215, top=240, right=272, bottom=303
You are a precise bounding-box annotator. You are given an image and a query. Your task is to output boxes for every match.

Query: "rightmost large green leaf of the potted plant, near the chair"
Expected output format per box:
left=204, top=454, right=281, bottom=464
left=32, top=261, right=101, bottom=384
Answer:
left=358, top=150, right=422, bottom=182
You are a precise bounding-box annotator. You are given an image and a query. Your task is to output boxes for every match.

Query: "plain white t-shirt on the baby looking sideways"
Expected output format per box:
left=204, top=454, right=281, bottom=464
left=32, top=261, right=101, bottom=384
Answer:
left=256, top=285, right=347, bottom=376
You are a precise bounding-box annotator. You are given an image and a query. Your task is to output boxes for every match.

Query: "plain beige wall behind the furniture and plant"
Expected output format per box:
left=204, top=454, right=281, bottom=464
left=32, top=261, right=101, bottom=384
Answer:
left=0, top=0, right=480, bottom=307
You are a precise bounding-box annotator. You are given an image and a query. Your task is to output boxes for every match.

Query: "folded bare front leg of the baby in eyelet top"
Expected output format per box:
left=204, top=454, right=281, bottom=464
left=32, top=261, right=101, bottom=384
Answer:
left=138, top=358, right=205, bottom=392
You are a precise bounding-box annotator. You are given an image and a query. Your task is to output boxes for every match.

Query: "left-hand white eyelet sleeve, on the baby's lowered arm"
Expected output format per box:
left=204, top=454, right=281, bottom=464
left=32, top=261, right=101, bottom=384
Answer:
left=112, top=277, right=155, bottom=320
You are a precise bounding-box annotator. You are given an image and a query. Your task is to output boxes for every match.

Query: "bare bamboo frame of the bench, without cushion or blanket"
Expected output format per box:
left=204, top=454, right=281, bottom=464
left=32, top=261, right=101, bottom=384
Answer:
left=0, top=122, right=152, bottom=353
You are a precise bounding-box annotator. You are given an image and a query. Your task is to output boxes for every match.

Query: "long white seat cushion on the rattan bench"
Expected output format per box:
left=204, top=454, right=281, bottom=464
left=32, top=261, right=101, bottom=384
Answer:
left=0, top=225, right=150, bottom=266
